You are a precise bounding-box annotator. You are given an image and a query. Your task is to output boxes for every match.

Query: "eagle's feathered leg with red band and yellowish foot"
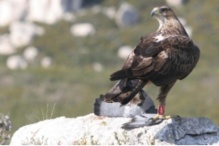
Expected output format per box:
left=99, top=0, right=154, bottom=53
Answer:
left=151, top=82, right=175, bottom=123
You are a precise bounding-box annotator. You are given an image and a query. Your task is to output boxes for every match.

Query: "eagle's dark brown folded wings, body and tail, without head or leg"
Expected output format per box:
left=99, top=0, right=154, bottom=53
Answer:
left=105, top=35, right=199, bottom=104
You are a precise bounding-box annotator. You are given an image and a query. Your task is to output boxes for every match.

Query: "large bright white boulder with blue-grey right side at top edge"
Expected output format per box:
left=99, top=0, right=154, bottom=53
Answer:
left=27, top=0, right=83, bottom=24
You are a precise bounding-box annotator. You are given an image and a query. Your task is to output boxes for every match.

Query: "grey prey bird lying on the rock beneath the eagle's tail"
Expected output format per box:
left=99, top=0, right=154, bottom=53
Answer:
left=94, top=90, right=157, bottom=118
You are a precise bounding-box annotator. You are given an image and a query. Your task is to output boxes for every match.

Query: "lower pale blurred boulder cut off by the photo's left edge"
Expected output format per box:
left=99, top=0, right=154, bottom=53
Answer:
left=0, top=34, right=16, bottom=55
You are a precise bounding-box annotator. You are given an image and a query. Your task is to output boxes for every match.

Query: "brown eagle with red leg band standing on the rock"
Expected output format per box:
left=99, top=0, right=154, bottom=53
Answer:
left=104, top=6, right=200, bottom=125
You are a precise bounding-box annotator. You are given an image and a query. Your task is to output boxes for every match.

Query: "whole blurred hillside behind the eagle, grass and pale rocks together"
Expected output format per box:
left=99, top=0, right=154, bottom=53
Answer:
left=0, top=0, right=219, bottom=135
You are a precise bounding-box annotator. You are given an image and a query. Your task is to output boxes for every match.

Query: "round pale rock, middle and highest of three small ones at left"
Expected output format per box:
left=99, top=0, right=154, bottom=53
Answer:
left=23, top=47, right=38, bottom=61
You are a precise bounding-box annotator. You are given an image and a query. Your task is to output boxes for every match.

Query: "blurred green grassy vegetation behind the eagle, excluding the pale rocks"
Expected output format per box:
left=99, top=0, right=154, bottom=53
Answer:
left=0, top=0, right=219, bottom=135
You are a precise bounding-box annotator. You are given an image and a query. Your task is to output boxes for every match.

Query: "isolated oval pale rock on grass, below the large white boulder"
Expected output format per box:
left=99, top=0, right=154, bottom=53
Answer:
left=71, top=23, right=95, bottom=37
